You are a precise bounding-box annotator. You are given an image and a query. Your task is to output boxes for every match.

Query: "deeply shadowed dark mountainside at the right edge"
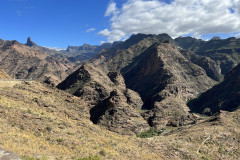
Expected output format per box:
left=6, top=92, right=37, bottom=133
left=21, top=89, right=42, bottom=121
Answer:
left=188, top=65, right=240, bottom=115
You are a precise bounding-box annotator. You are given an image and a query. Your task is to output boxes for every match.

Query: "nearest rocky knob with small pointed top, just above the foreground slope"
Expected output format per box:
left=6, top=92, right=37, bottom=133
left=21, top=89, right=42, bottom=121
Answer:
left=91, top=90, right=149, bottom=135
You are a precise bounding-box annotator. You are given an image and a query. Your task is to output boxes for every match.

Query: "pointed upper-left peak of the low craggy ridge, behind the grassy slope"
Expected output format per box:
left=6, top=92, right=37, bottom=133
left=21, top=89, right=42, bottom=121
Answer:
left=57, top=64, right=114, bottom=105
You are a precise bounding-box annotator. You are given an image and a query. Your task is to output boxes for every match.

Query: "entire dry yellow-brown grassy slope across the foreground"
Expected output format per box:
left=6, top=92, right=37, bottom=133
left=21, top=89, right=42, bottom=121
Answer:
left=0, top=82, right=240, bottom=160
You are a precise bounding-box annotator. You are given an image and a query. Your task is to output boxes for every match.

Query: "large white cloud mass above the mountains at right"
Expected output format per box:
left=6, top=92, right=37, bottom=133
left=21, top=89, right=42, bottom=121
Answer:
left=99, top=0, right=240, bottom=42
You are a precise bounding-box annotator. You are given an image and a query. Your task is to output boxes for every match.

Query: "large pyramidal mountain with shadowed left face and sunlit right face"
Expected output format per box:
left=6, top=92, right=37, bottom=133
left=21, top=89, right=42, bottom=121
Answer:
left=123, top=43, right=213, bottom=101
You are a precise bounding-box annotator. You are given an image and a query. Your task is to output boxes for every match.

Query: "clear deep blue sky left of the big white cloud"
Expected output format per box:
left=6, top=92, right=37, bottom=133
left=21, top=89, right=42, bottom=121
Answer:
left=0, top=0, right=123, bottom=48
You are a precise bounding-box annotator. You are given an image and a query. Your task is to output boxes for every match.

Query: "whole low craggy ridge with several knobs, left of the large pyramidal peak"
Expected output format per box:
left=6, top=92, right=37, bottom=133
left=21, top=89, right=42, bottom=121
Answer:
left=57, top=63, right=149, bottom=135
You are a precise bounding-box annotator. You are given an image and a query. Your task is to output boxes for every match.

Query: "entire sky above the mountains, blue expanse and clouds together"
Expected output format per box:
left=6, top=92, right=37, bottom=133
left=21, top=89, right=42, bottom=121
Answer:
left=0, top=0, right=240, bottom=48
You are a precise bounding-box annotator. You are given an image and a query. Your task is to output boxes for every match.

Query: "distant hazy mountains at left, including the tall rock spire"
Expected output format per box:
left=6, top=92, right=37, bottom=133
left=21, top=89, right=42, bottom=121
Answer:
left=0, top=37, right=117, bottom=85
